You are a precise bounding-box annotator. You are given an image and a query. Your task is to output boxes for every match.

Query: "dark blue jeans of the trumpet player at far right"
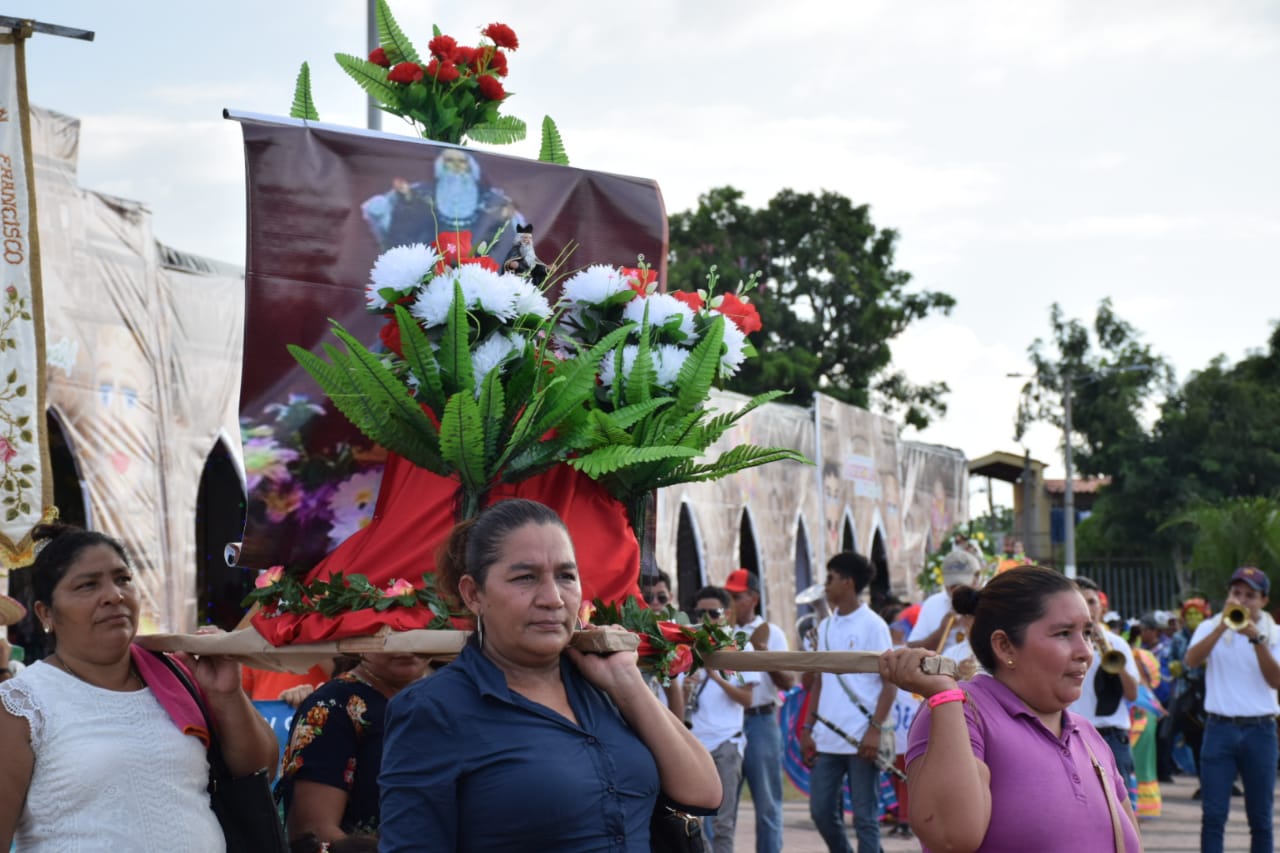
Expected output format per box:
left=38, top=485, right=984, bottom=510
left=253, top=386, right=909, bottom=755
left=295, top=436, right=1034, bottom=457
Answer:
left=1201, top=719, right=1276, bottom=853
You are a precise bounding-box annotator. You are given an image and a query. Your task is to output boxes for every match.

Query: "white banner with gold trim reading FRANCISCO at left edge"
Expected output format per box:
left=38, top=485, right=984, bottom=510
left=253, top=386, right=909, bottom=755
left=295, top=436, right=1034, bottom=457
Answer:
left=0, top=33, right=56, bottom=578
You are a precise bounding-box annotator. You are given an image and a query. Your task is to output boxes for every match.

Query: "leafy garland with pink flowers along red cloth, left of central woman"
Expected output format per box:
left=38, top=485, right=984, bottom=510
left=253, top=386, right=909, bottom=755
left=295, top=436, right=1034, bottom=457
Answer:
left=241, top=566, right=457, bottom=629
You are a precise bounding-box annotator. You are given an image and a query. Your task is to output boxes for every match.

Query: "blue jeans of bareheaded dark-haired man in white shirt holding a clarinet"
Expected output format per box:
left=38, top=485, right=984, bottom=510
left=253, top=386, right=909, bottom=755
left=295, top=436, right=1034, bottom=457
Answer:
left=809, top=752, right=881, bottom=853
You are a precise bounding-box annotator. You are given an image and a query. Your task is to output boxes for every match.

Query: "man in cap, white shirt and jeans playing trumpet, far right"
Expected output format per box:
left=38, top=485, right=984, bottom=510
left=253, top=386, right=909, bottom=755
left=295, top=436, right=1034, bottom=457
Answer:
left=1183, top=566, right=1280, bottom=853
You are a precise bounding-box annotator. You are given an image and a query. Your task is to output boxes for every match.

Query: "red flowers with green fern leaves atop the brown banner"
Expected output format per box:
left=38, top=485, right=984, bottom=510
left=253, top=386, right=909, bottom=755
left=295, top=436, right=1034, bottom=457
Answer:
left=289, top=0, right=568, bottom=165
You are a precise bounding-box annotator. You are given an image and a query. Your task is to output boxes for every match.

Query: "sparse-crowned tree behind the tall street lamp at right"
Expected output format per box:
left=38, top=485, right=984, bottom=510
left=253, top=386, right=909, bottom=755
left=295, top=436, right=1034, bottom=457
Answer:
left=1014, top=298, right=1172, bottom=476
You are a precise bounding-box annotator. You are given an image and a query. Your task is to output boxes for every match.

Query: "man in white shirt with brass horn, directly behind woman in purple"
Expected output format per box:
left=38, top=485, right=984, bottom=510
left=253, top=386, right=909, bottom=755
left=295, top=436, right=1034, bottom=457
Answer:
left=1069, top=578, right=1139, bottom=794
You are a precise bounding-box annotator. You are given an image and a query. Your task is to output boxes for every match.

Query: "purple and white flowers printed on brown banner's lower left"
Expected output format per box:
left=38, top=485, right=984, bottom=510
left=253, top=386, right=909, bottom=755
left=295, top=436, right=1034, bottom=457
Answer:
left=241, top=394, right=387, bottom=566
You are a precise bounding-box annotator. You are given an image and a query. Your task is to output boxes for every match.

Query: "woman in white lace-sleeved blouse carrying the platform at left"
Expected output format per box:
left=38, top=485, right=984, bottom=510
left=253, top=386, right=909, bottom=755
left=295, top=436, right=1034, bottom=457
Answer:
left=0, top=525, right=276, bottom=853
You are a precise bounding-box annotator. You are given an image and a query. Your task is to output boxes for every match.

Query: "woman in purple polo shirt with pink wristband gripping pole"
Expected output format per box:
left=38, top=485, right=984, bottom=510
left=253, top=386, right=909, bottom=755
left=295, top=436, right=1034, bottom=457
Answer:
left=881, top=566, right=1142, bottom=853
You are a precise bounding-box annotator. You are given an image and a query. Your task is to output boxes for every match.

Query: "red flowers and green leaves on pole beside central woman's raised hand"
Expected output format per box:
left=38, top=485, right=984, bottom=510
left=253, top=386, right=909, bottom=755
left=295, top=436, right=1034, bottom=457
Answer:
left=590, top=597, right=746, bottom=685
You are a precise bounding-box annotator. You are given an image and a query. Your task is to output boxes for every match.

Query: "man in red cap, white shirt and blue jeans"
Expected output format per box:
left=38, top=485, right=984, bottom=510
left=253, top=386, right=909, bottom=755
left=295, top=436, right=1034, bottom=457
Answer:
left=724, top=569, right=795, bottom=853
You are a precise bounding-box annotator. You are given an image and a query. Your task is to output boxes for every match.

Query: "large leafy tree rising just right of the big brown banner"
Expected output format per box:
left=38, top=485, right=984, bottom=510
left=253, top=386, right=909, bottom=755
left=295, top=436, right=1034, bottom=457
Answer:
left=668, top=187, right=955, bottom=428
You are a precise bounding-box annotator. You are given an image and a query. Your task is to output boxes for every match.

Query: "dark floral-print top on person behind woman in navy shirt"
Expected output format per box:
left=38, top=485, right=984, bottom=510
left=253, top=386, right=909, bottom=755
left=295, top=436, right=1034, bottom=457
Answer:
left=276, top=670, right=387, bottom=835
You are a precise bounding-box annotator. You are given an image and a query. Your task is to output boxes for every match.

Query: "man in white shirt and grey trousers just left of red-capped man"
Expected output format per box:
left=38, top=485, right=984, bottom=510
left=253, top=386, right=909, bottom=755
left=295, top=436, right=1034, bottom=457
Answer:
left=685, top=587, right=760, bottom=853
